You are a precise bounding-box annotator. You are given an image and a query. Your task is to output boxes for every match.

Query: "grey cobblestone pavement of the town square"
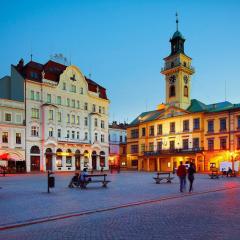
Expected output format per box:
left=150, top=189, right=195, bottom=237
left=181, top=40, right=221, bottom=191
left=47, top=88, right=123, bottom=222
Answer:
left=0, top=172, right=240, bottom=240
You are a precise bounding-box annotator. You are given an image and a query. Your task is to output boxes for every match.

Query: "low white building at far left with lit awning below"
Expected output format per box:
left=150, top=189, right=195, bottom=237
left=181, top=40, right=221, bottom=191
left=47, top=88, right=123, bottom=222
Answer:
left=0, top=99, right=26, bottom=172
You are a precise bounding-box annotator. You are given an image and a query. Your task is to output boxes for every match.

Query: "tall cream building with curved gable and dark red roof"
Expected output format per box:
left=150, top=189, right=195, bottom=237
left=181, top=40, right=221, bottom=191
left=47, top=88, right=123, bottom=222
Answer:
left=0, top=60, right=109, bottom=172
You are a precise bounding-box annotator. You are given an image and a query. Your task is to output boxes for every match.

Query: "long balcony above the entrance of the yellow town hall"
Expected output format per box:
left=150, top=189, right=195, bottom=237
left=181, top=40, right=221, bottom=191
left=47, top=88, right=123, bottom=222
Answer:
left=144, top=147, right=204, bottom=156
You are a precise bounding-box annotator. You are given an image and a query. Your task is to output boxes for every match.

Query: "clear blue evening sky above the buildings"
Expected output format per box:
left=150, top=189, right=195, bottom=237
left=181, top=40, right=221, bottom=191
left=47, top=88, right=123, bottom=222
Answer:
left=0, top=0, right=240, bottom=121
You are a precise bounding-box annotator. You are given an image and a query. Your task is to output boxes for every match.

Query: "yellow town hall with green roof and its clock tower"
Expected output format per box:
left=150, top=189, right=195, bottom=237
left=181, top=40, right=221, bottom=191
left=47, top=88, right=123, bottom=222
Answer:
left=127, top=19, right=240, bottom=172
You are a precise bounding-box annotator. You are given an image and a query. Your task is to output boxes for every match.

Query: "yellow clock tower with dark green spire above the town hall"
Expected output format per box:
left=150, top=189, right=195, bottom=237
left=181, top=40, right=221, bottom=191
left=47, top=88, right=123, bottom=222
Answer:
left=161, top=14, right=194, bottom=109
